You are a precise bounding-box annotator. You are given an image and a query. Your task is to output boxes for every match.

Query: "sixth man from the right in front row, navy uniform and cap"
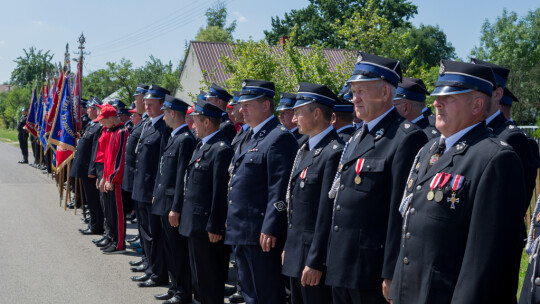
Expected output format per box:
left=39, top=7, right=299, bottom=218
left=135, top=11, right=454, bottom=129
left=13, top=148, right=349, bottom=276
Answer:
left=152, top=95, right=197, bottom=303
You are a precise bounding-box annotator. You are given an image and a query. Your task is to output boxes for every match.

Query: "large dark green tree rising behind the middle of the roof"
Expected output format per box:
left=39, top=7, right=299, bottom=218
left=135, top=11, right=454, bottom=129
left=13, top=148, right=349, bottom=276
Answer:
left=264, top=0, right=417, bottom=48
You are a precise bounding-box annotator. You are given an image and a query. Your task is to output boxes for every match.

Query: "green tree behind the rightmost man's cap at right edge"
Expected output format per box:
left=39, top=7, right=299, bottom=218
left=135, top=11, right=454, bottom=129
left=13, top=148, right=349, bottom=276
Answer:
left=471, top=8, right=540, bottom=125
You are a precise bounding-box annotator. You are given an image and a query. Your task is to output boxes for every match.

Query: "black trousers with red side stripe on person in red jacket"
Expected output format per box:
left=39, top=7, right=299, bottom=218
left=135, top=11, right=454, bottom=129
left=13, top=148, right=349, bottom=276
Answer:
left=105, top=184, right=126, bottom=250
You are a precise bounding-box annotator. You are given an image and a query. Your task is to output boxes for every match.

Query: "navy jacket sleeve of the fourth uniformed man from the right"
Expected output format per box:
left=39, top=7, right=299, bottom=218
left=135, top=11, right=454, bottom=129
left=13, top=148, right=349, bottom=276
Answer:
left=261, top=133, right=298, bottom=241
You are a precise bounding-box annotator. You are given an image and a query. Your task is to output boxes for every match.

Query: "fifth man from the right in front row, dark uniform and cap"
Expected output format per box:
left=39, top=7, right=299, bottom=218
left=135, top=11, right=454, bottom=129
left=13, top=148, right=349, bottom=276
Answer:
left=179, top=100, right=234, bottom=304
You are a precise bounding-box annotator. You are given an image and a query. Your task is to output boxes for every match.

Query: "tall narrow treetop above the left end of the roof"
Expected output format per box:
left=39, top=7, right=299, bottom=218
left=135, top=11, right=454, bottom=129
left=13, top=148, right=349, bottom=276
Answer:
left=195, top=1, right=236, bottom=42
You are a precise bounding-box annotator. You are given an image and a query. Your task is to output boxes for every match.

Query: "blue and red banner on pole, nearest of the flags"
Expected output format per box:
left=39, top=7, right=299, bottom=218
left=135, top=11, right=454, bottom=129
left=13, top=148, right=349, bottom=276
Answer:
left=49, top=76, right=75, bottom=169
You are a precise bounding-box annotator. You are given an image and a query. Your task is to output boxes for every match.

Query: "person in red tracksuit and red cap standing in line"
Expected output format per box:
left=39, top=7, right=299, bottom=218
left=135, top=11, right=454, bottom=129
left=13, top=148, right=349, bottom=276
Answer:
left=95, top=106, right=129, bottom=254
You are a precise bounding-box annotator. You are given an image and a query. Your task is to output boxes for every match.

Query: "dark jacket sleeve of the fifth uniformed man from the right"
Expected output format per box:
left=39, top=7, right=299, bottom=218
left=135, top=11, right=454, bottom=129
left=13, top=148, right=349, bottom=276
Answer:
left=206, top=145, right=234, bottom=235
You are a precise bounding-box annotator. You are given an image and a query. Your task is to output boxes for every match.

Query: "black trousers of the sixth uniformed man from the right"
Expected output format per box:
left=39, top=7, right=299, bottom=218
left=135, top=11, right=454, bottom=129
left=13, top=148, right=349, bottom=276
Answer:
left=160, top=215, right=192, bottom=303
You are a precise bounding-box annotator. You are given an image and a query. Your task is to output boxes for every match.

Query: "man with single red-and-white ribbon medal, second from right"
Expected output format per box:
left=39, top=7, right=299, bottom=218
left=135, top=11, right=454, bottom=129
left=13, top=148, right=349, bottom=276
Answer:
left=326, top=52, right=427, bottom=304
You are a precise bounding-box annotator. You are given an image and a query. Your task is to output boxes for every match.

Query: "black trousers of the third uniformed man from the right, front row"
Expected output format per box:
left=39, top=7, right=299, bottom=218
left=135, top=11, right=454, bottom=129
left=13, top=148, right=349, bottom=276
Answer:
left=290, top=273, right=332, bottom=304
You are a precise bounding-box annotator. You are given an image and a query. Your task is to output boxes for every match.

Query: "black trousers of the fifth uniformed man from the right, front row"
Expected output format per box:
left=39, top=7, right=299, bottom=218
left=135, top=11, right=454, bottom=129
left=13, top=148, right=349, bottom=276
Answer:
left=188, top=237, right=230, bottom=304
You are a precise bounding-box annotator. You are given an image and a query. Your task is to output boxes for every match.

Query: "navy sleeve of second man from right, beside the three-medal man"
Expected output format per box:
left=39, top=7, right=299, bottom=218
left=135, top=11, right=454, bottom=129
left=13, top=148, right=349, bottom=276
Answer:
left=382, top=129, right=427, bottom=280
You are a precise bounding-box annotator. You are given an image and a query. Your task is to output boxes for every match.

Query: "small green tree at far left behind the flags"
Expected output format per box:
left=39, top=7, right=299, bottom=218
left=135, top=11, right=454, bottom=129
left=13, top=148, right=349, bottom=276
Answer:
left=11, top=46, right=54, bottom=86
